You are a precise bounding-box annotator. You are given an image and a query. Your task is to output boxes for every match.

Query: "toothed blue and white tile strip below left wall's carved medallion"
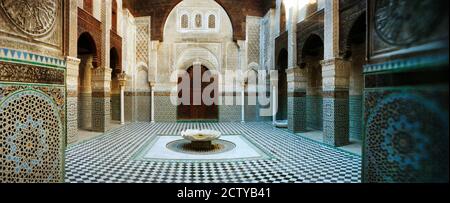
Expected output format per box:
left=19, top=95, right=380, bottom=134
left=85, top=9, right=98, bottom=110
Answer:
left=0, top=48, right=67, bottom=69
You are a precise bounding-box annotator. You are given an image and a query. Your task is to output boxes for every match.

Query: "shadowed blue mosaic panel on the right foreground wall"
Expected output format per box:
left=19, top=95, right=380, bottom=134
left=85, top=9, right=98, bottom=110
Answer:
left=364, top=89, right=449, bottom=183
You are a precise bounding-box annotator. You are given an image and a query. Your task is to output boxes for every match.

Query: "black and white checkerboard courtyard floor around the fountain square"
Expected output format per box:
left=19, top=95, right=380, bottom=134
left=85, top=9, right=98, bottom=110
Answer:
left=66, top=123, right=361, bottom=183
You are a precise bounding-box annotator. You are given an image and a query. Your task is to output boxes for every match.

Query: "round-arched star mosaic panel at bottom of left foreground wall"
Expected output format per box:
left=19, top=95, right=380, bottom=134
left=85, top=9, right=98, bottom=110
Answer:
left=0, top=85, right=65, bottom=183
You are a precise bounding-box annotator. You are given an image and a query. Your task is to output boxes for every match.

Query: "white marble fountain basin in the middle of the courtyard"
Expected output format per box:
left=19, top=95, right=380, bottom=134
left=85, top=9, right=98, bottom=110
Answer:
left=181, top=130, right=222, bottom=151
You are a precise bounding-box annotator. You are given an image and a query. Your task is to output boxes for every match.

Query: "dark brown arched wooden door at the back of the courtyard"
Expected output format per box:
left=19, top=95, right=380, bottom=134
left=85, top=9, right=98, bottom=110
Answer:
left=177, top=65, right=219, bottom=121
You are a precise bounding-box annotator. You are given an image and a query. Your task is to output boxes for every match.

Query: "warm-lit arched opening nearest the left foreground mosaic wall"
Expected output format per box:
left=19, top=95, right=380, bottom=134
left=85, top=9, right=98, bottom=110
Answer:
left=77, top=33, right=97, bottom=130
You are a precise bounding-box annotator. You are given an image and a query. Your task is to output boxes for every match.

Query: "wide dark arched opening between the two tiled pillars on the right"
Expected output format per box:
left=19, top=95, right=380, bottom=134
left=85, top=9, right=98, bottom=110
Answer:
left=302, top=34, right=324, bottom=130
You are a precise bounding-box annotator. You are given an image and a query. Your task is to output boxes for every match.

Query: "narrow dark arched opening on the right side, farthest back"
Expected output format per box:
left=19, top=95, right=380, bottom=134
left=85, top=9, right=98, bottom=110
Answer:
left=277, top=49, right=288, bottom=121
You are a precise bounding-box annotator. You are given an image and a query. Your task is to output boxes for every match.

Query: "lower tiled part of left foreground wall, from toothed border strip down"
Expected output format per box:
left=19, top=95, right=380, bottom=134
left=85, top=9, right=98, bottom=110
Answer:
left=0, top=48, right=66, bottom=183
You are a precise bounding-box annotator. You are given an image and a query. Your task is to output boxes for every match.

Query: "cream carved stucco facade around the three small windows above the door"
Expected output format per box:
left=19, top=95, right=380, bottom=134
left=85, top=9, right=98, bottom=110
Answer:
left=156, top=0, right=237, bottom=92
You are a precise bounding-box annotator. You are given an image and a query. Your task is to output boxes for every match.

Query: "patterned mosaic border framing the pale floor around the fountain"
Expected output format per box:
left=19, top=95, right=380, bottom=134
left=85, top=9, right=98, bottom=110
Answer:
left=131, top=134, right=275, bottom=163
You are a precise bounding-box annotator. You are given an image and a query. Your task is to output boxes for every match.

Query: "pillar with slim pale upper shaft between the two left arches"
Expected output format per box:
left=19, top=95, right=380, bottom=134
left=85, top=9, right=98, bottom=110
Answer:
left=92, top=0, right=112, bottom=132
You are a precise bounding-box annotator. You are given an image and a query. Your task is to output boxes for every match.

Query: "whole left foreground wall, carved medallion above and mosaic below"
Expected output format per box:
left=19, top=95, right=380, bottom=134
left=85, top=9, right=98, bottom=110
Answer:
left=0, top=0, right=66, bottom=182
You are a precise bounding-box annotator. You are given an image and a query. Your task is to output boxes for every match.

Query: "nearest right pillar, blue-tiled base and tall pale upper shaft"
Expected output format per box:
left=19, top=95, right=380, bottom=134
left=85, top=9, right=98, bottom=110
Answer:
left=321, top=1, right=351, bottom=147
